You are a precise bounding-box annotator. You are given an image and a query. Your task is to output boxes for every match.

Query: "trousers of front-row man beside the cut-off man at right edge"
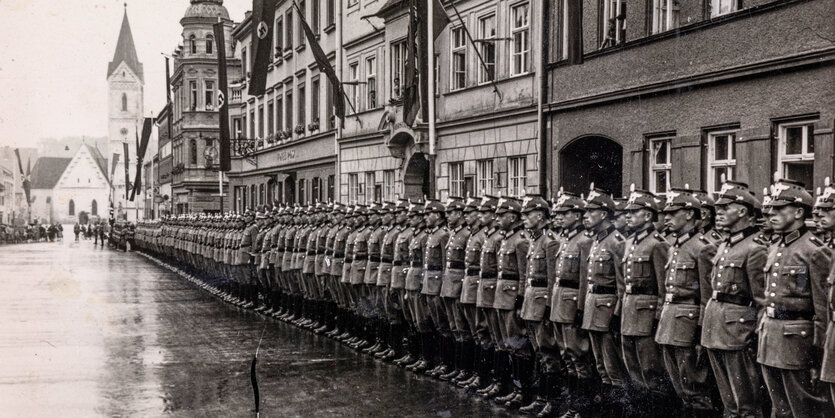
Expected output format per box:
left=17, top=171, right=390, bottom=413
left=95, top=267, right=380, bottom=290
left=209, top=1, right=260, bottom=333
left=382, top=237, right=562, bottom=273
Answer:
left=760, top=365, right=835, bottom=417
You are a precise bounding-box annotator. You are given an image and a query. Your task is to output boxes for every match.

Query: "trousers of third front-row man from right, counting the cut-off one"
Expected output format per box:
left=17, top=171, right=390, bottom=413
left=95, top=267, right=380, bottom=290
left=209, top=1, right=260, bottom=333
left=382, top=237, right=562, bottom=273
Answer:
left=707, top=349, right=762, bottom=417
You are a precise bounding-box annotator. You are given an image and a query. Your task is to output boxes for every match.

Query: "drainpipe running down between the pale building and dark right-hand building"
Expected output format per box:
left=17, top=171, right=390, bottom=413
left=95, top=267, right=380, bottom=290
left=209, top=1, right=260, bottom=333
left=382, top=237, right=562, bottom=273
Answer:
left=536, top=0, right=551, bottom=199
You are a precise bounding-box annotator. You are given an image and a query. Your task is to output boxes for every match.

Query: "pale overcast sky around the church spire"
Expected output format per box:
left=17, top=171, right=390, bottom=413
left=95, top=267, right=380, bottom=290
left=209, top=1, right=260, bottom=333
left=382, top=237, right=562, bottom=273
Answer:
left=0, top=0, right=252, bottom=146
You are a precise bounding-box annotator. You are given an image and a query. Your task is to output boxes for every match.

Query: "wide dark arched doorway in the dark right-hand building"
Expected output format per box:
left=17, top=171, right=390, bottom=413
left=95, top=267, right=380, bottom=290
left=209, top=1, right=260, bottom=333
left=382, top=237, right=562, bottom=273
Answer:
left=559, top=136, right=623, bottom=197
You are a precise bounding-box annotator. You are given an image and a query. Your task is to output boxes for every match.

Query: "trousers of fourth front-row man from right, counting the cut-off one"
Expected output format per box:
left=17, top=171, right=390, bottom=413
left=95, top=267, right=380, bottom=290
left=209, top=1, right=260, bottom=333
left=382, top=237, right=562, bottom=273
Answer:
left=661, top=345, right=713, bottom=410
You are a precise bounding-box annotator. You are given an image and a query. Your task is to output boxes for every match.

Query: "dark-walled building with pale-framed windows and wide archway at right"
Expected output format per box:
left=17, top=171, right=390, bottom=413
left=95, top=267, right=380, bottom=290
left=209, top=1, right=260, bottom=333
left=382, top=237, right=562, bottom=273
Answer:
left=543, top=0, right=835, bottom=195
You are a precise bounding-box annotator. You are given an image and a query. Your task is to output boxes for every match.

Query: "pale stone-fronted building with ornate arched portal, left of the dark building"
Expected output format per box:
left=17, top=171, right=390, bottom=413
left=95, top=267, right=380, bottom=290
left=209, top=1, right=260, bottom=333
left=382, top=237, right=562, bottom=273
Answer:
left=339, top=0, right=540, bottom=202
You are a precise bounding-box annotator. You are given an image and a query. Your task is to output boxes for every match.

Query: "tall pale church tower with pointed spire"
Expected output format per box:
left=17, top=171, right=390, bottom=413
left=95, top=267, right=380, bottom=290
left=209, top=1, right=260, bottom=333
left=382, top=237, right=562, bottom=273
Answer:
left=106, top=5, right=145, bottom=221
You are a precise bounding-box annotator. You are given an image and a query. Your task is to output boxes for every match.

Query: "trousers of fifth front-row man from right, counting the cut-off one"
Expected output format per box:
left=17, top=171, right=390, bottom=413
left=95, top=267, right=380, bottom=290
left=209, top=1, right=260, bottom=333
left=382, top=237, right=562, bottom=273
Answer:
left=621, top=335, right=670, bottom=394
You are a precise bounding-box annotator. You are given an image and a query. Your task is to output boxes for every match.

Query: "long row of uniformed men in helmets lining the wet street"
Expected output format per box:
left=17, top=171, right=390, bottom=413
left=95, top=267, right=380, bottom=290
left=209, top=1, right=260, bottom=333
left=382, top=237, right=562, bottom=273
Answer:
left=137, top=176, right=835, bottom=416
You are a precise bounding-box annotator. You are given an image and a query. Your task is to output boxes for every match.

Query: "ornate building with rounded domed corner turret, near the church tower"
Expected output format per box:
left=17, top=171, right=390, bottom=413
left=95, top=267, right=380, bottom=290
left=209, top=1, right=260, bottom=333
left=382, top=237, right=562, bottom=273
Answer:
left=170, top=0, right=237, bottom=213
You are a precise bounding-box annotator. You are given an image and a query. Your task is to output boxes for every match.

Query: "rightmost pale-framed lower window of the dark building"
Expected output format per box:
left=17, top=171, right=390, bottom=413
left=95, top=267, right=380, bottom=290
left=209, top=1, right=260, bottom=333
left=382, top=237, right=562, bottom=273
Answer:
left=777, top=122, right=815, bottom=188
